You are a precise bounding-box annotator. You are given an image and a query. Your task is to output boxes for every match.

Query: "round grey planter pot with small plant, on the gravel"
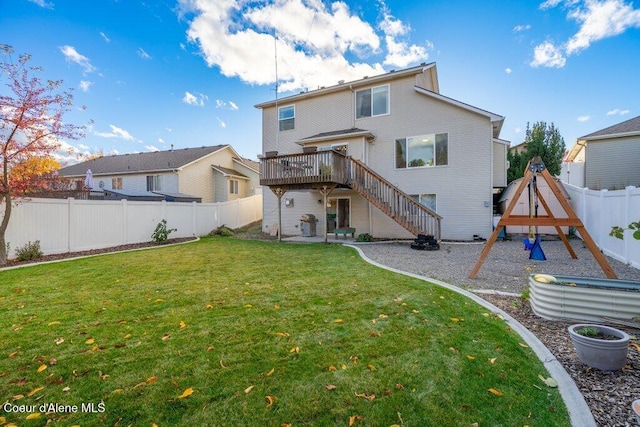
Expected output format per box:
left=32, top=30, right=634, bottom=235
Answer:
left=569, top=323, right=629, bottom=371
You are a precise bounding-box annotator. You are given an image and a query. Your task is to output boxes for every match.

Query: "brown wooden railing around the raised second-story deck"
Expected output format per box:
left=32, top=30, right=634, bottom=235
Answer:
left=260, top=151, right=347, bottom=186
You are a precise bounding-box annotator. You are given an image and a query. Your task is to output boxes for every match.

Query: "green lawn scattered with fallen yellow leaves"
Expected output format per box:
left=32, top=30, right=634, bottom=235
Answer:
left=0, top=237, right=569, bottom=426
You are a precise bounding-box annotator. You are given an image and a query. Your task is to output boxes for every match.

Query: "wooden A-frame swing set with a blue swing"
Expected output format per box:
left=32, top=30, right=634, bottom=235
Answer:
left=469, top=156, right=617, bottom=279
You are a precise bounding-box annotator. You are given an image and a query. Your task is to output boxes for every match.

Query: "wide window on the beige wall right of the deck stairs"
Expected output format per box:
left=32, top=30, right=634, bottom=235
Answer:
left=396, top=133, right=449, bottom=169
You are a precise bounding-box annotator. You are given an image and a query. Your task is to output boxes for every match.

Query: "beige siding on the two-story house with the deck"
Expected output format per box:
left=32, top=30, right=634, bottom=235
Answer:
left=263, top=70, right=495, bottom=239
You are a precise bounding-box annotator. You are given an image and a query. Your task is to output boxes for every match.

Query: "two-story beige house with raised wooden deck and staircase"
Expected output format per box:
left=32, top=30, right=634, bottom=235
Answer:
left=256, top=63, right=509, bottom=240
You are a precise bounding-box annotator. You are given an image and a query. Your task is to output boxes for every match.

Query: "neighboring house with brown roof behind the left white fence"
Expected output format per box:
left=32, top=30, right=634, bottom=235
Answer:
left=58, top=145, right=260, bottom=203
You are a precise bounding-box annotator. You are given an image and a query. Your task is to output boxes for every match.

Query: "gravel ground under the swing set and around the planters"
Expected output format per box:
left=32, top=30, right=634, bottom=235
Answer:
left=359, top=240, right=640, bottom=427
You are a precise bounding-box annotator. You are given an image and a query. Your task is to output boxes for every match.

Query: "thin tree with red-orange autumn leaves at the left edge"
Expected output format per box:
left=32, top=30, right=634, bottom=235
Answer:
left=0, top=44, right=84, bottom=265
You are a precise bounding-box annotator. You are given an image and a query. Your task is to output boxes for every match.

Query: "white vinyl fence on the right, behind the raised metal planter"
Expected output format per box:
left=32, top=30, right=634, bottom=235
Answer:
left=563, top=183, right=640, bottom=268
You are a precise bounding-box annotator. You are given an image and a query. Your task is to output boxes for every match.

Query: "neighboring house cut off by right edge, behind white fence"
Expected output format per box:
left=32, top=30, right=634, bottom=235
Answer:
left=561, top=116, right=640, bottom=190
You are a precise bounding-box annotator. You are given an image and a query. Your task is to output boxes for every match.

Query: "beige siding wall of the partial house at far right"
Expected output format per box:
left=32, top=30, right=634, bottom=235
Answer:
left=585, top=136, right=640, bottom=190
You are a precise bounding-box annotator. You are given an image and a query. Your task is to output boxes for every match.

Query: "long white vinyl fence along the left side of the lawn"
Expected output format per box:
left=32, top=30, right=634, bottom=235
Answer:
left=0, top=195, right=262, bottom=258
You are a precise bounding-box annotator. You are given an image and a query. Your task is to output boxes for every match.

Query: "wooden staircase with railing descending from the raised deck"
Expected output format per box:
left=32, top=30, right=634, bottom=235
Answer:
left=346, top=157, right=442, bottom=240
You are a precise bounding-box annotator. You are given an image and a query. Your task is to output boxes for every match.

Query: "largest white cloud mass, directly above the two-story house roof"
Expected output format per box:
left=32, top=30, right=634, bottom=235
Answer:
left=179, top=0, right=424, bottom=91
